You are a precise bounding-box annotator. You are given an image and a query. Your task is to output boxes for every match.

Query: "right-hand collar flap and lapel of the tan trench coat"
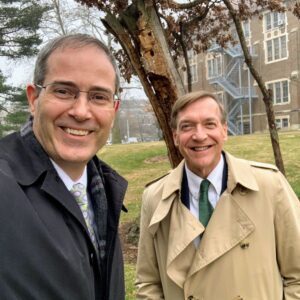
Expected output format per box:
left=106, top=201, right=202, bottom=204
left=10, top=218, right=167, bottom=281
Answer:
left=188, top=153, right=258, bottom=277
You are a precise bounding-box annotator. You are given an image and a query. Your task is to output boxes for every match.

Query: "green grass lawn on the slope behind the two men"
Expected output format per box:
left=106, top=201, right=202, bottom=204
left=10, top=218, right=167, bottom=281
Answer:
left=99, top=131, right=300, bottom=300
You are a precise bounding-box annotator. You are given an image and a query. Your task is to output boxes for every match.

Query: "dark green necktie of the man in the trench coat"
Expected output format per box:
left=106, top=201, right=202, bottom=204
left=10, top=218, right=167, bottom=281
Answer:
left=199, top=179, right=213, bottom=227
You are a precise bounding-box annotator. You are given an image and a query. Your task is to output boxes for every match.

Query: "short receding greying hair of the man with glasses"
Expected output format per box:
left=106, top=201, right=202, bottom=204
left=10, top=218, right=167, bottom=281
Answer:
left=33, top=33, right=120, bottom=94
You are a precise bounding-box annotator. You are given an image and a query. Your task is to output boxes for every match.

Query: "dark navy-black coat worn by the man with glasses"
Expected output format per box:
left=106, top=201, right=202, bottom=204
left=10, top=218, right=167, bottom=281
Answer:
left=0, top=133, right=127, bottom=300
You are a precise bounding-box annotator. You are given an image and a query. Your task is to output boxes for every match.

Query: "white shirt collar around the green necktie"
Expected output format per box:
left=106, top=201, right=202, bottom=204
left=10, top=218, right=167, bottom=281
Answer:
left=185, top=155, right=225, bottom=199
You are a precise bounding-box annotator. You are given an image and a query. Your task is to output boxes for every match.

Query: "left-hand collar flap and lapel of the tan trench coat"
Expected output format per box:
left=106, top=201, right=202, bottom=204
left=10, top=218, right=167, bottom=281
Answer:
left=149, top=161, right=204, bottom=287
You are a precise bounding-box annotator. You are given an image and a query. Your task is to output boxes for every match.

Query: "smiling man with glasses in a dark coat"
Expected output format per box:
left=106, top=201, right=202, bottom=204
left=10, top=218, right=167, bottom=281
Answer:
left=0, top=34, right=127, bottom=300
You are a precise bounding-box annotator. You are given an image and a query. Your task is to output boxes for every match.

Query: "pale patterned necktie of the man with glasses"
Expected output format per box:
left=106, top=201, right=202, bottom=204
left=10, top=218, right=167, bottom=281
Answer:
left=70, top=183, right=98, bottom=249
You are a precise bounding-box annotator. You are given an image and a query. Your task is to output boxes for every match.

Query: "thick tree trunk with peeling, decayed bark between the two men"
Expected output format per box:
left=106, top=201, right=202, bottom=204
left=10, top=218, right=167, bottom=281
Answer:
left=103, top=0, right=184, bottom=167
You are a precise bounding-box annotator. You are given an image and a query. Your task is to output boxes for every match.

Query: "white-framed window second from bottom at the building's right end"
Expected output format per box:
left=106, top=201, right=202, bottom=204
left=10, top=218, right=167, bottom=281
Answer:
left=266, top=78, right=291, bottom=105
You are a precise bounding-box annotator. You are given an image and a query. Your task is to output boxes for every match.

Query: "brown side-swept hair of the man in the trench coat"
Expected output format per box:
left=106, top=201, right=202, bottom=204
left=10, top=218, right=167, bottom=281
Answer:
left=170, top=90, right=227, bottom=129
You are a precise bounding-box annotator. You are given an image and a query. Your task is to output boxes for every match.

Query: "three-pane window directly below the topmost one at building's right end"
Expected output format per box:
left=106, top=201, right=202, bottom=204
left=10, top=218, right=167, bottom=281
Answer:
left=266, top=35, right=287, bottom=62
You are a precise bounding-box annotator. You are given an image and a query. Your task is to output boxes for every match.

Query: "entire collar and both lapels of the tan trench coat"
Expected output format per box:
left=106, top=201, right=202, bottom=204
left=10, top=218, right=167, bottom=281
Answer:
left=149, top=152, right=258, bottom=288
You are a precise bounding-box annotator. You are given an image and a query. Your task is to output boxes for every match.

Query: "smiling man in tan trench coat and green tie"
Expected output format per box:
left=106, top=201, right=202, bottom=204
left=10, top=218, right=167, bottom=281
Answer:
left=136, top=91, right=300, bottom=300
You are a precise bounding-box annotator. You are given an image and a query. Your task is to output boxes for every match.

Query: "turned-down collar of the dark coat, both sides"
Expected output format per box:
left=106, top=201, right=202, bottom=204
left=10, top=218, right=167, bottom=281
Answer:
left=0, top=129, right=127, bottom=234
